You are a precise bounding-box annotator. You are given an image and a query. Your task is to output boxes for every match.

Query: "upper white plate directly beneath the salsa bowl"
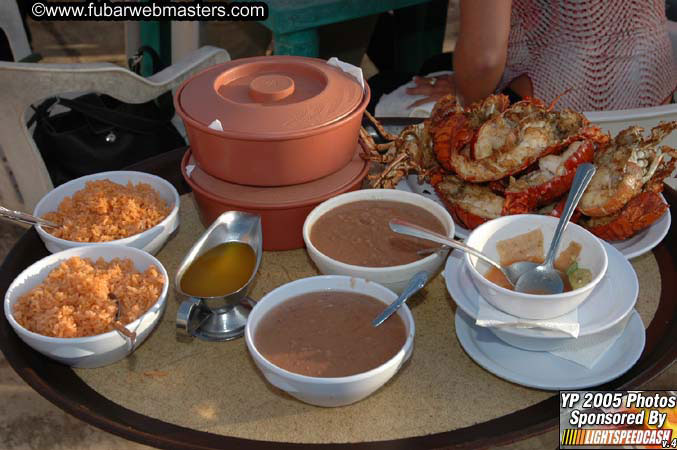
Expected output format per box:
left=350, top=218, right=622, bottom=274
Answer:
left=444, top=241, right=639, bottom=339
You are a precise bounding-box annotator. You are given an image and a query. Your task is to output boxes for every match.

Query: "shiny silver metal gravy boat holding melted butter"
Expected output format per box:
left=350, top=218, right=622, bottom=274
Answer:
left=174, top=211, right=263, bottom=341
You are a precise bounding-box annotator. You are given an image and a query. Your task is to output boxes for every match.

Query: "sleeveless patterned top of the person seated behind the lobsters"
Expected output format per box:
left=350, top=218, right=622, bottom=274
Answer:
left=499, top=0, right=677, bottom=111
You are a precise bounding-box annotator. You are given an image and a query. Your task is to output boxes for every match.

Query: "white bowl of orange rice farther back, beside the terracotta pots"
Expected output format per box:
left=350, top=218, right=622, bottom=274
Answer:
left=33, top=170, right=179, bottom=254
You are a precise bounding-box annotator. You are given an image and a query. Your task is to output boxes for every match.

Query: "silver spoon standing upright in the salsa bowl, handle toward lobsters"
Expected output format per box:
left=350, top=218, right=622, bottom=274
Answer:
left=515, top=163, right=595, bottom=295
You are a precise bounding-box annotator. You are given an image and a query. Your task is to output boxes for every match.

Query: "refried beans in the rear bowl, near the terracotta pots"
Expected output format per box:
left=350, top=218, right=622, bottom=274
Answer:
left=310, top=200, right=446, bottom=267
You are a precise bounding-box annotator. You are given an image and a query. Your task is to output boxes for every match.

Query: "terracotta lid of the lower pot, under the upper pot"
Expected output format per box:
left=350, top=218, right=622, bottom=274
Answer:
left=181, top=146, right=369, bottom=209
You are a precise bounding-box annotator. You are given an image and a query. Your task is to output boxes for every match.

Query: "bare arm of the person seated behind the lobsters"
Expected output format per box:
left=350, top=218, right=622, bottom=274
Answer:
left=454, top=0, right=512, bottom=104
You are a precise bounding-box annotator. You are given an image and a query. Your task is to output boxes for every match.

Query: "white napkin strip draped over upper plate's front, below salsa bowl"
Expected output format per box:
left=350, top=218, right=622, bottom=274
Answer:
left=475, top=297, right=581, bottom=338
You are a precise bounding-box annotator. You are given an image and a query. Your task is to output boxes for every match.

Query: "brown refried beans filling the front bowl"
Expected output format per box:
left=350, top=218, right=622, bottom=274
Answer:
left=254, top=291, right=407, bottom=377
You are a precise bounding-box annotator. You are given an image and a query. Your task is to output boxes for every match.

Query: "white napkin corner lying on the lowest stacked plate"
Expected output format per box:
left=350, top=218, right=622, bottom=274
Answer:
left=550, top=312, right=632, bottom=369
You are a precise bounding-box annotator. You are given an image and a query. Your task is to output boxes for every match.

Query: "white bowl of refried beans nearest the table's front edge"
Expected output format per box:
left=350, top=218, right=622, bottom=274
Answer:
left=245, top=275, right=415, bottom=407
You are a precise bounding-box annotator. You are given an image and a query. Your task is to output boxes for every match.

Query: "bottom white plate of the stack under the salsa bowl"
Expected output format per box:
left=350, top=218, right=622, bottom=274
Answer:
left=455, top=311, right=645, bottom=391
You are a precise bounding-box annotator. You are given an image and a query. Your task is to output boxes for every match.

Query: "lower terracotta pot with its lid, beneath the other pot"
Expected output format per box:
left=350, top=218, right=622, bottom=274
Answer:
left=181, top=146, right=369, bottom=250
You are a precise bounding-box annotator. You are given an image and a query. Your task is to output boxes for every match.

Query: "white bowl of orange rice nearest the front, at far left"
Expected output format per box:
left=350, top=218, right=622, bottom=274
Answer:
left=4, top=245, right=169, bottom=368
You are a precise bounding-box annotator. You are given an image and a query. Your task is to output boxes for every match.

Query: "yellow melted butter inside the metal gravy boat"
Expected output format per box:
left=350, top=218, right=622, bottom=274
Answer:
left=181, top=242, right=256, bottom=297
